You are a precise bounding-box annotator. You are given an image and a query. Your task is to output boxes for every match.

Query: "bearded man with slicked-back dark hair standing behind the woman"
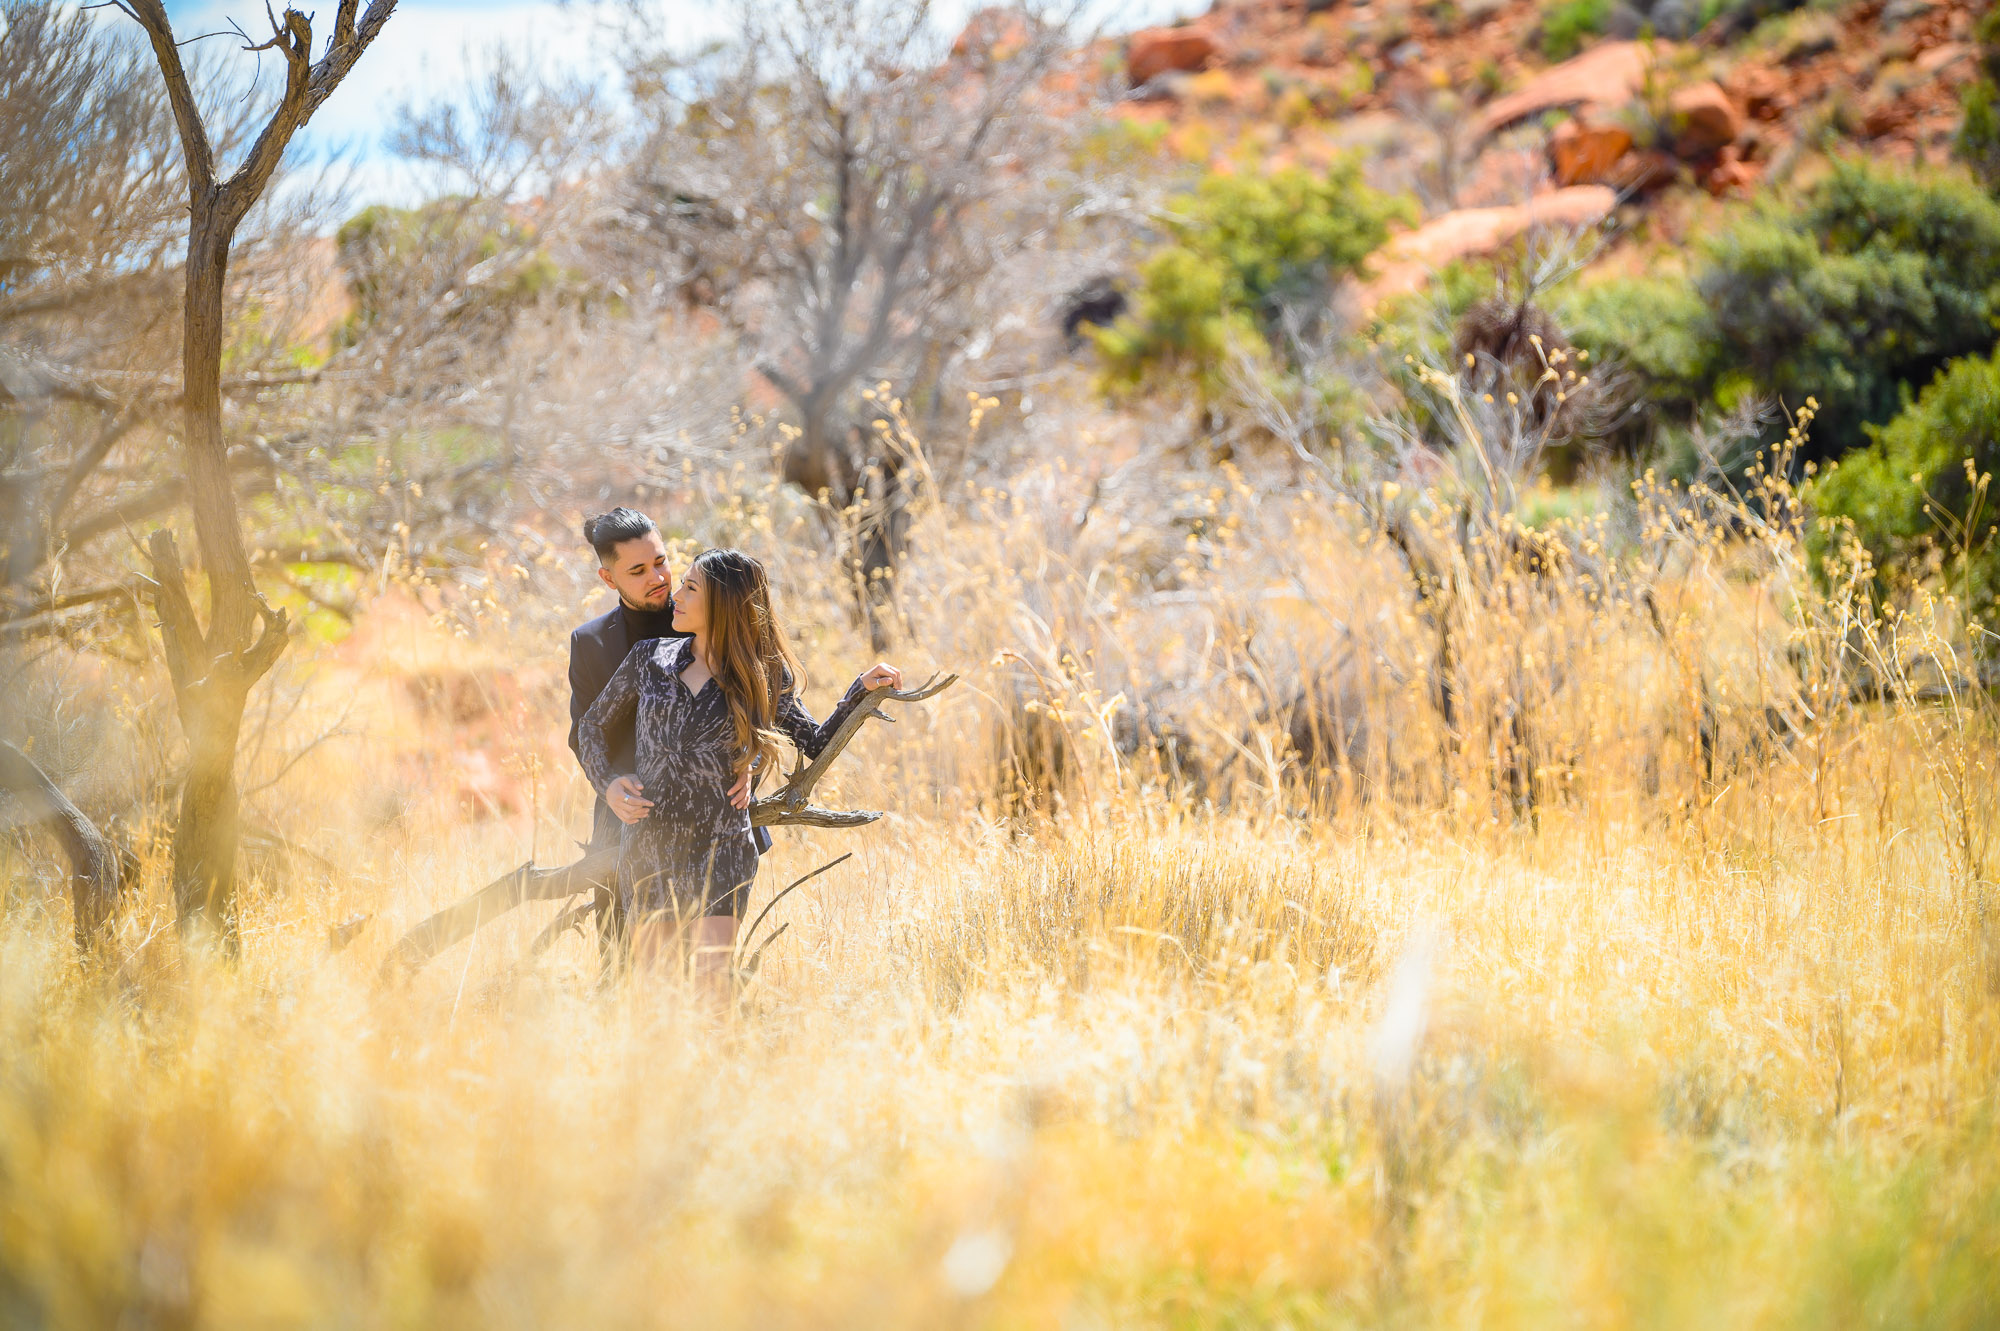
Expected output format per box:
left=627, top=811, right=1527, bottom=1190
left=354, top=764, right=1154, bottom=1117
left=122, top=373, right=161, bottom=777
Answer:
left=570, top=508, right=770, bottom=853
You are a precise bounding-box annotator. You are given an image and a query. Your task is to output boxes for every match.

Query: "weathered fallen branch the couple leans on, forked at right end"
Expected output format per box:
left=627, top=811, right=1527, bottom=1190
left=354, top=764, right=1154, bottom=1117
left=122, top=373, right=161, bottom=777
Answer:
left=382, top=675, right=958, bottom=979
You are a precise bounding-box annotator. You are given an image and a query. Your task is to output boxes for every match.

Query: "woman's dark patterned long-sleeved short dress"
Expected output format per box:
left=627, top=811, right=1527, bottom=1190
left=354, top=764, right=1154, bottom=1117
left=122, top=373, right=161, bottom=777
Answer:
left=576, top=638, right=866, bottom=919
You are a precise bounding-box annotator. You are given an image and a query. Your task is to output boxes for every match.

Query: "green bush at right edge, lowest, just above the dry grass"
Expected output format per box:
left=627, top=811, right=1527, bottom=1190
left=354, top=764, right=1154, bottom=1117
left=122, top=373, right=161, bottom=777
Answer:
left=1806, top=354, right=2000, bottom=626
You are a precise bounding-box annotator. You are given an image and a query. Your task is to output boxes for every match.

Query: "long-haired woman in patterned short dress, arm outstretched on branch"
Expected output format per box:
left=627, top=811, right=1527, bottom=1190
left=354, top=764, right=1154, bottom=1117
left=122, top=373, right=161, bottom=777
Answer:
left=576, top=550, right=902, bottom=987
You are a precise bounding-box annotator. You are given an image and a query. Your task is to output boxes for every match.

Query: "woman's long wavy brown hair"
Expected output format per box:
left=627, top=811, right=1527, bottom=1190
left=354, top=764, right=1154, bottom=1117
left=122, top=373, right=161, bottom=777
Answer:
left=694, top=550, right=806, bottom=773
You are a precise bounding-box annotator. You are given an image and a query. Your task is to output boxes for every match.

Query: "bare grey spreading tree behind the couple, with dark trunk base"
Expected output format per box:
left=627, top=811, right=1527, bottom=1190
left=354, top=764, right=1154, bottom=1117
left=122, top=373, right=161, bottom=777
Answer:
left=624, top=0, right=1072, bottom=644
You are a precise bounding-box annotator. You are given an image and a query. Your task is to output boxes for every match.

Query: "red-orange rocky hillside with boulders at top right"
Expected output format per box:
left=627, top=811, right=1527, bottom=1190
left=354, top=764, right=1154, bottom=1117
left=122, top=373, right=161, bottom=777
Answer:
left=1104, top=0, right=1976, bottom=293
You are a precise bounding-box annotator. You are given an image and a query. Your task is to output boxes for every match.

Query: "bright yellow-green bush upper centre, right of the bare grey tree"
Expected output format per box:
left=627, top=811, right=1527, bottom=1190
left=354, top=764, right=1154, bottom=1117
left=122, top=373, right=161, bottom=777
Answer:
left=1092, top=160, right=1410, bottom=398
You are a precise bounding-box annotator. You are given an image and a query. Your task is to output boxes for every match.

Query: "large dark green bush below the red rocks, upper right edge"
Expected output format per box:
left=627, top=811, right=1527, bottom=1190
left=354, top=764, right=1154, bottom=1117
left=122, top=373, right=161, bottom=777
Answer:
left=1566, top=162, right=2000, bottom=456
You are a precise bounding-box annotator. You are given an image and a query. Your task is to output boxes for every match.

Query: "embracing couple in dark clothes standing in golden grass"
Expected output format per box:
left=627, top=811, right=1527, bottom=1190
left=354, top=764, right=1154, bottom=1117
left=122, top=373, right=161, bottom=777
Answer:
left=570, top=508, right=902, bottom=987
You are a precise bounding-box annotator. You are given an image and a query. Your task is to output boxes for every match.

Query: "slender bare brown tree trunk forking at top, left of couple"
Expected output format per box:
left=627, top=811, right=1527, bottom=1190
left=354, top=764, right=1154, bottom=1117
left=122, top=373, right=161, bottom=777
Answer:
left=114, top=0, right=396, bottom=951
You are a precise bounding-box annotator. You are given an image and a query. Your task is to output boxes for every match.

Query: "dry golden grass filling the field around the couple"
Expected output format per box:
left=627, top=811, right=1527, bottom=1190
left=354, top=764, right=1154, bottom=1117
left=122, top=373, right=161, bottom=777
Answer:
left=0, top=429, right=2000, bottom=1327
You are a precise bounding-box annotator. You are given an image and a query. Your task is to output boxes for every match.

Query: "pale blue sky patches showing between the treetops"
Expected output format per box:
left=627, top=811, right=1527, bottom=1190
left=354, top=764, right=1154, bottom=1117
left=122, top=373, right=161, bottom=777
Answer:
left=152, top=0, right=1208, bottom=204
